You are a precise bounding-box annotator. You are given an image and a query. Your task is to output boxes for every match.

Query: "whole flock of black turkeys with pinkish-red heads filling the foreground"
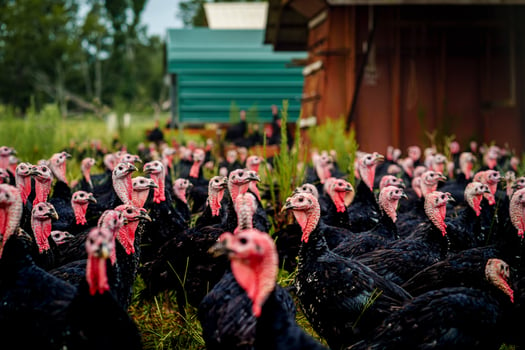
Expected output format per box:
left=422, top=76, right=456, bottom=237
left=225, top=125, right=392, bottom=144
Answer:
left=0, top=138, right=525, bottom=350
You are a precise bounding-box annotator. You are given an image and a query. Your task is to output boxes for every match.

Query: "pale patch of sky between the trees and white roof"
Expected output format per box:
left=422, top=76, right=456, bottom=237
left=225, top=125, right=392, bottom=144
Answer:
left=142, top=0, right=182, bottom=38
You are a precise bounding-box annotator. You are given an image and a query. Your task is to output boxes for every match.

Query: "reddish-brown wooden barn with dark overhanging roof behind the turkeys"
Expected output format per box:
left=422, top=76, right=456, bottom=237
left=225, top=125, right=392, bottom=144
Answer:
left=265, top=0, right=525, bottom=152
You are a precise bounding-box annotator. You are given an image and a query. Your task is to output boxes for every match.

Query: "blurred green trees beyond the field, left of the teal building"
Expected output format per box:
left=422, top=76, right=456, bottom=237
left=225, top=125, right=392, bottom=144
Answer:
left=0, top=0, right=166, bottom=116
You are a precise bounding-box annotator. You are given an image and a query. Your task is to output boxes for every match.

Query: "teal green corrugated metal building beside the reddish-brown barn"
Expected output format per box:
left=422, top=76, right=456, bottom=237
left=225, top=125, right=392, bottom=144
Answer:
left=166, top=28, right=307, bottom=123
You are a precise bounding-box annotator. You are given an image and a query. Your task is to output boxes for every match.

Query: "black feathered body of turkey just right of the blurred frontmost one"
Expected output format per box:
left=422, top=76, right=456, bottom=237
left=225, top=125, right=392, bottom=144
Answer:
left=295, top=226, right=410, bottom=349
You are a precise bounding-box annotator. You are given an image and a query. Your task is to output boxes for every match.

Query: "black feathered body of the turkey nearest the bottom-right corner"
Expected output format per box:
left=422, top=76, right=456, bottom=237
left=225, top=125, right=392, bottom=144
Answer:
left=350, top=287, right=510, bottom=350
